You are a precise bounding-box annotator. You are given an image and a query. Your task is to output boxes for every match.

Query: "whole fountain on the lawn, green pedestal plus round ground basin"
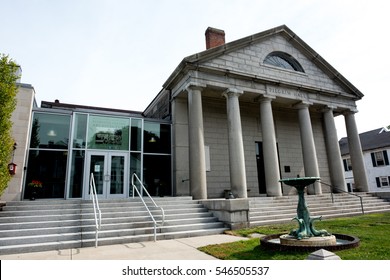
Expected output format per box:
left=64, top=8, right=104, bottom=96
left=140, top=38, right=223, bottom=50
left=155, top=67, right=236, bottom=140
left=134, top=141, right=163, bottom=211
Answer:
left=260, top=177, right=359, bottom=251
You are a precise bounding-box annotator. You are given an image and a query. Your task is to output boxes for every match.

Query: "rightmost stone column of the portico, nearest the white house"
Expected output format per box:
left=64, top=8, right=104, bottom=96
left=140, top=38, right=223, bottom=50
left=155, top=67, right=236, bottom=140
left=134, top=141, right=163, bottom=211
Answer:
left=344, top=112, right=368, bottom=192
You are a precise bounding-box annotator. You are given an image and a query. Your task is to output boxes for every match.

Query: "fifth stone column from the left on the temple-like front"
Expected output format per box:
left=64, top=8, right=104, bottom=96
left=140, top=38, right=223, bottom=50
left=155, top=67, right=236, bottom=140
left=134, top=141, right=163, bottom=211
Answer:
left=324, top=108, right=348, bottom=192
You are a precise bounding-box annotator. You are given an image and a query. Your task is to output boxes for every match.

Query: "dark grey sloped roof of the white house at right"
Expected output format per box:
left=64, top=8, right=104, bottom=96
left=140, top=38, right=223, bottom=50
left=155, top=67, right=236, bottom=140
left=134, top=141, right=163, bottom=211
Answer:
left=339, top=128, right=390, bottom=155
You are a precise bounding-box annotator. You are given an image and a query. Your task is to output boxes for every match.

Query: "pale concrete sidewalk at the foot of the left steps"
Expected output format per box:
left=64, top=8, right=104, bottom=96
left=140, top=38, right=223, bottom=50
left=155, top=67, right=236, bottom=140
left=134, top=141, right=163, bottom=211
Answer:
left=0, top=234, right=246, bottom=260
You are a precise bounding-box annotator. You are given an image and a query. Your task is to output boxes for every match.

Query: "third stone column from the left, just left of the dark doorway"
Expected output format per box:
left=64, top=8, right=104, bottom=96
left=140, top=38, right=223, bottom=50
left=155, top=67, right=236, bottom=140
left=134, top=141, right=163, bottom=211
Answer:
left=260, top=97, right=282, bottom=196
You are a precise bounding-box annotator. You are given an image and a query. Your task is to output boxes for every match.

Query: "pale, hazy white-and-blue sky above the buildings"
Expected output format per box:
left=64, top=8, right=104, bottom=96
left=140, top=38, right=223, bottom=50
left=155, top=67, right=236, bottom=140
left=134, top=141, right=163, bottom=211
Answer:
left=0, top=0, right=390, bottom=138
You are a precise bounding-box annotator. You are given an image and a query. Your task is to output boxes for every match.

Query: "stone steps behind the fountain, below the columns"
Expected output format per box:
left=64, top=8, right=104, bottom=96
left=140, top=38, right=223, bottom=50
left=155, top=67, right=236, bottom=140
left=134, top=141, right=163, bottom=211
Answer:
left=249, top=193, right=390, bottom=227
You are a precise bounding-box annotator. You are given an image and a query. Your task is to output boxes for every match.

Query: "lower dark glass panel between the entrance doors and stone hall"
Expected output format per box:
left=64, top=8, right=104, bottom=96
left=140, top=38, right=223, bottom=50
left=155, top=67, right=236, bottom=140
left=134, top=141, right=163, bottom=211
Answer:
left=144, top=155, right=172, bottom=196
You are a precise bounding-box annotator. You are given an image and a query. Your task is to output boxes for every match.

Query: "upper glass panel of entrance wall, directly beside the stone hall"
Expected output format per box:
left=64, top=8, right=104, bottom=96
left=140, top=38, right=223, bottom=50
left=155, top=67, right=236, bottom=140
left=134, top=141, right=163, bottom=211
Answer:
left=144, top=122, right=171, bottom=154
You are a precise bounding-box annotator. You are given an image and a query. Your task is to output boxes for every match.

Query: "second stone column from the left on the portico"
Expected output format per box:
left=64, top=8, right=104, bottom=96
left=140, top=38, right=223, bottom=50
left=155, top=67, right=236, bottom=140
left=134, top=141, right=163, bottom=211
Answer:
left=223, top=89, right=248, bottom=198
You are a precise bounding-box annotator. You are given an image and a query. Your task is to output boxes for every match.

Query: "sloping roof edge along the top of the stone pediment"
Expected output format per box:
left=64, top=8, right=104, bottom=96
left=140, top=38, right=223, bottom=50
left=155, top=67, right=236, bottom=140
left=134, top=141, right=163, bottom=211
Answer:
left=163, top=25, right=363, bottom=99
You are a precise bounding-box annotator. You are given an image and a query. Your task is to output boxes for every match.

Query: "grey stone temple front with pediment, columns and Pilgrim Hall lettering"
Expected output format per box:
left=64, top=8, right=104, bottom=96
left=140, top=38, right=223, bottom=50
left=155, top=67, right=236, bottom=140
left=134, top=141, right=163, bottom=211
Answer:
left=144, top=26, right=367, bottom=199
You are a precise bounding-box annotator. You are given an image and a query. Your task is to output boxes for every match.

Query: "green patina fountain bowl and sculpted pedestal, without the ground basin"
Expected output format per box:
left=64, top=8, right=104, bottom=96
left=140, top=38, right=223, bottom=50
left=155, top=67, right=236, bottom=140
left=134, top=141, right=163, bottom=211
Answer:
left=280, top=177, right=331, bottom=240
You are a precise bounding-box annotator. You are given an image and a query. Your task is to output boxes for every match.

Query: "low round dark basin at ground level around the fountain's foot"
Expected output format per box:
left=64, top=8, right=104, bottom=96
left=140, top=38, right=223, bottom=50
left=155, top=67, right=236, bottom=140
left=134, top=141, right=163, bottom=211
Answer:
left=260, top=233, right=360, bottom=252
